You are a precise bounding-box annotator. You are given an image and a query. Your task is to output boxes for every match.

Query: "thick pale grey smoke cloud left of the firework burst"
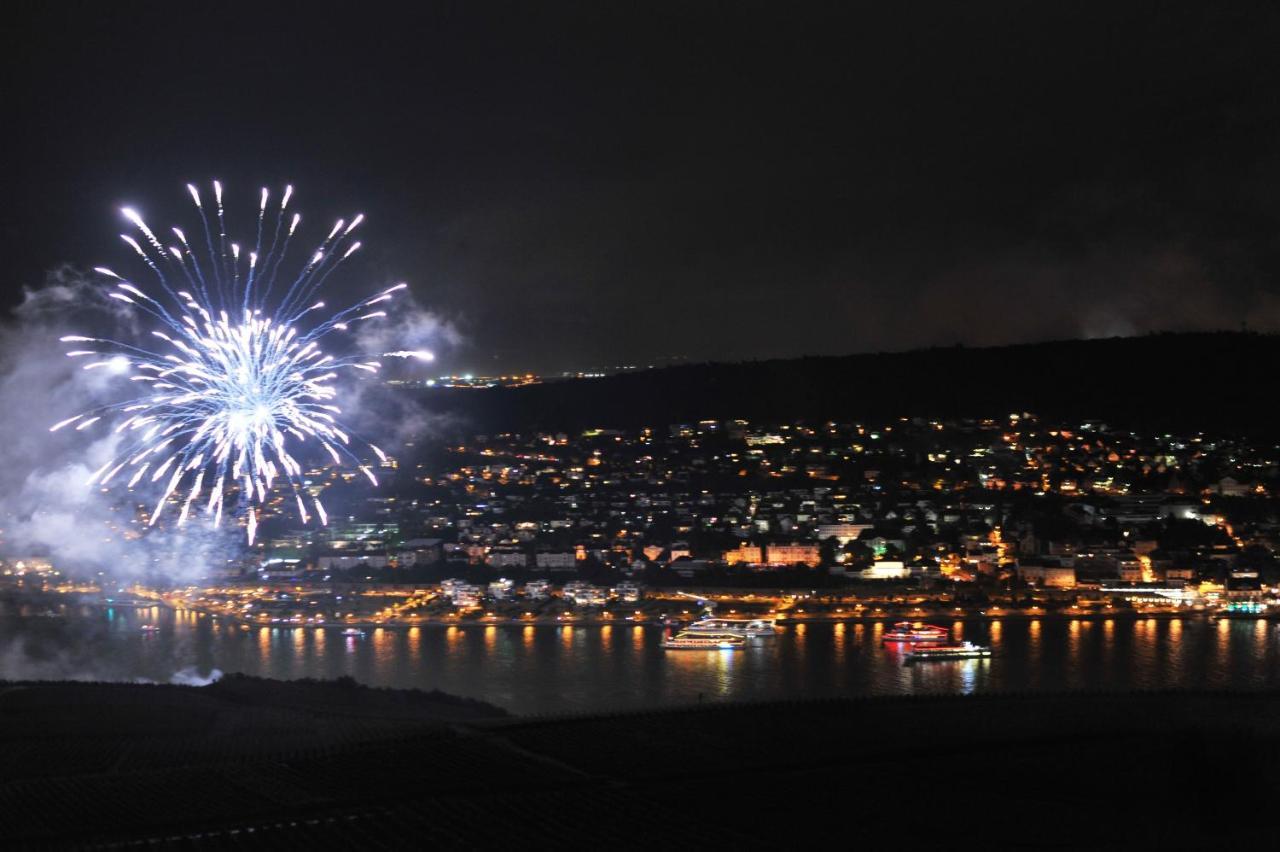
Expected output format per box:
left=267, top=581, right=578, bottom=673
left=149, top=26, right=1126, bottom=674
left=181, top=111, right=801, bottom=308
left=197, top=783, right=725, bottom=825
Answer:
left=0, top=266, right=236, bottom=582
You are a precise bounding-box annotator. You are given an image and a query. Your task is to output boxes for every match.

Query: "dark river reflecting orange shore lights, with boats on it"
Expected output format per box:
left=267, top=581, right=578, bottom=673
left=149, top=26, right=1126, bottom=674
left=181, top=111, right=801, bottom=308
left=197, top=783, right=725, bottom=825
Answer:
left=0, top=606, right=1280, bottom=714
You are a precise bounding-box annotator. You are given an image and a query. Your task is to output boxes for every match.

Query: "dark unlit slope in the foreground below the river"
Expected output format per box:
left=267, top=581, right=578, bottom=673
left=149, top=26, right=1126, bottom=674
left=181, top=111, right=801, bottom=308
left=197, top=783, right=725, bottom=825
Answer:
left=0, top=679, right=1280, bottom=849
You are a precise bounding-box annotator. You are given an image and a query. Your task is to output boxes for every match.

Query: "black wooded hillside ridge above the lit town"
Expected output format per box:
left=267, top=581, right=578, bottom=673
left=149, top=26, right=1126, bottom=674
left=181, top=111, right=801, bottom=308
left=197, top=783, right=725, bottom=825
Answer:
left=420, top=333, right=1280, bottom=435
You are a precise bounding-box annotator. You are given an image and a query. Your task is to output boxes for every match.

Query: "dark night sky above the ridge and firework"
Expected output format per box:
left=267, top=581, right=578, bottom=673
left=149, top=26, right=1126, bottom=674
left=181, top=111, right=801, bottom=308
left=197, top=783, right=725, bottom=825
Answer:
left=0, top=1, right=1280, bottom=371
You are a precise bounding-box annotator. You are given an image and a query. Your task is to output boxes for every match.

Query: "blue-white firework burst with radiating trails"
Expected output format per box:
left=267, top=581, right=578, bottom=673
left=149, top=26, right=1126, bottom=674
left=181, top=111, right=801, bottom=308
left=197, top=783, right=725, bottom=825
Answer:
left=50, top=180, right=431, bottom=544
